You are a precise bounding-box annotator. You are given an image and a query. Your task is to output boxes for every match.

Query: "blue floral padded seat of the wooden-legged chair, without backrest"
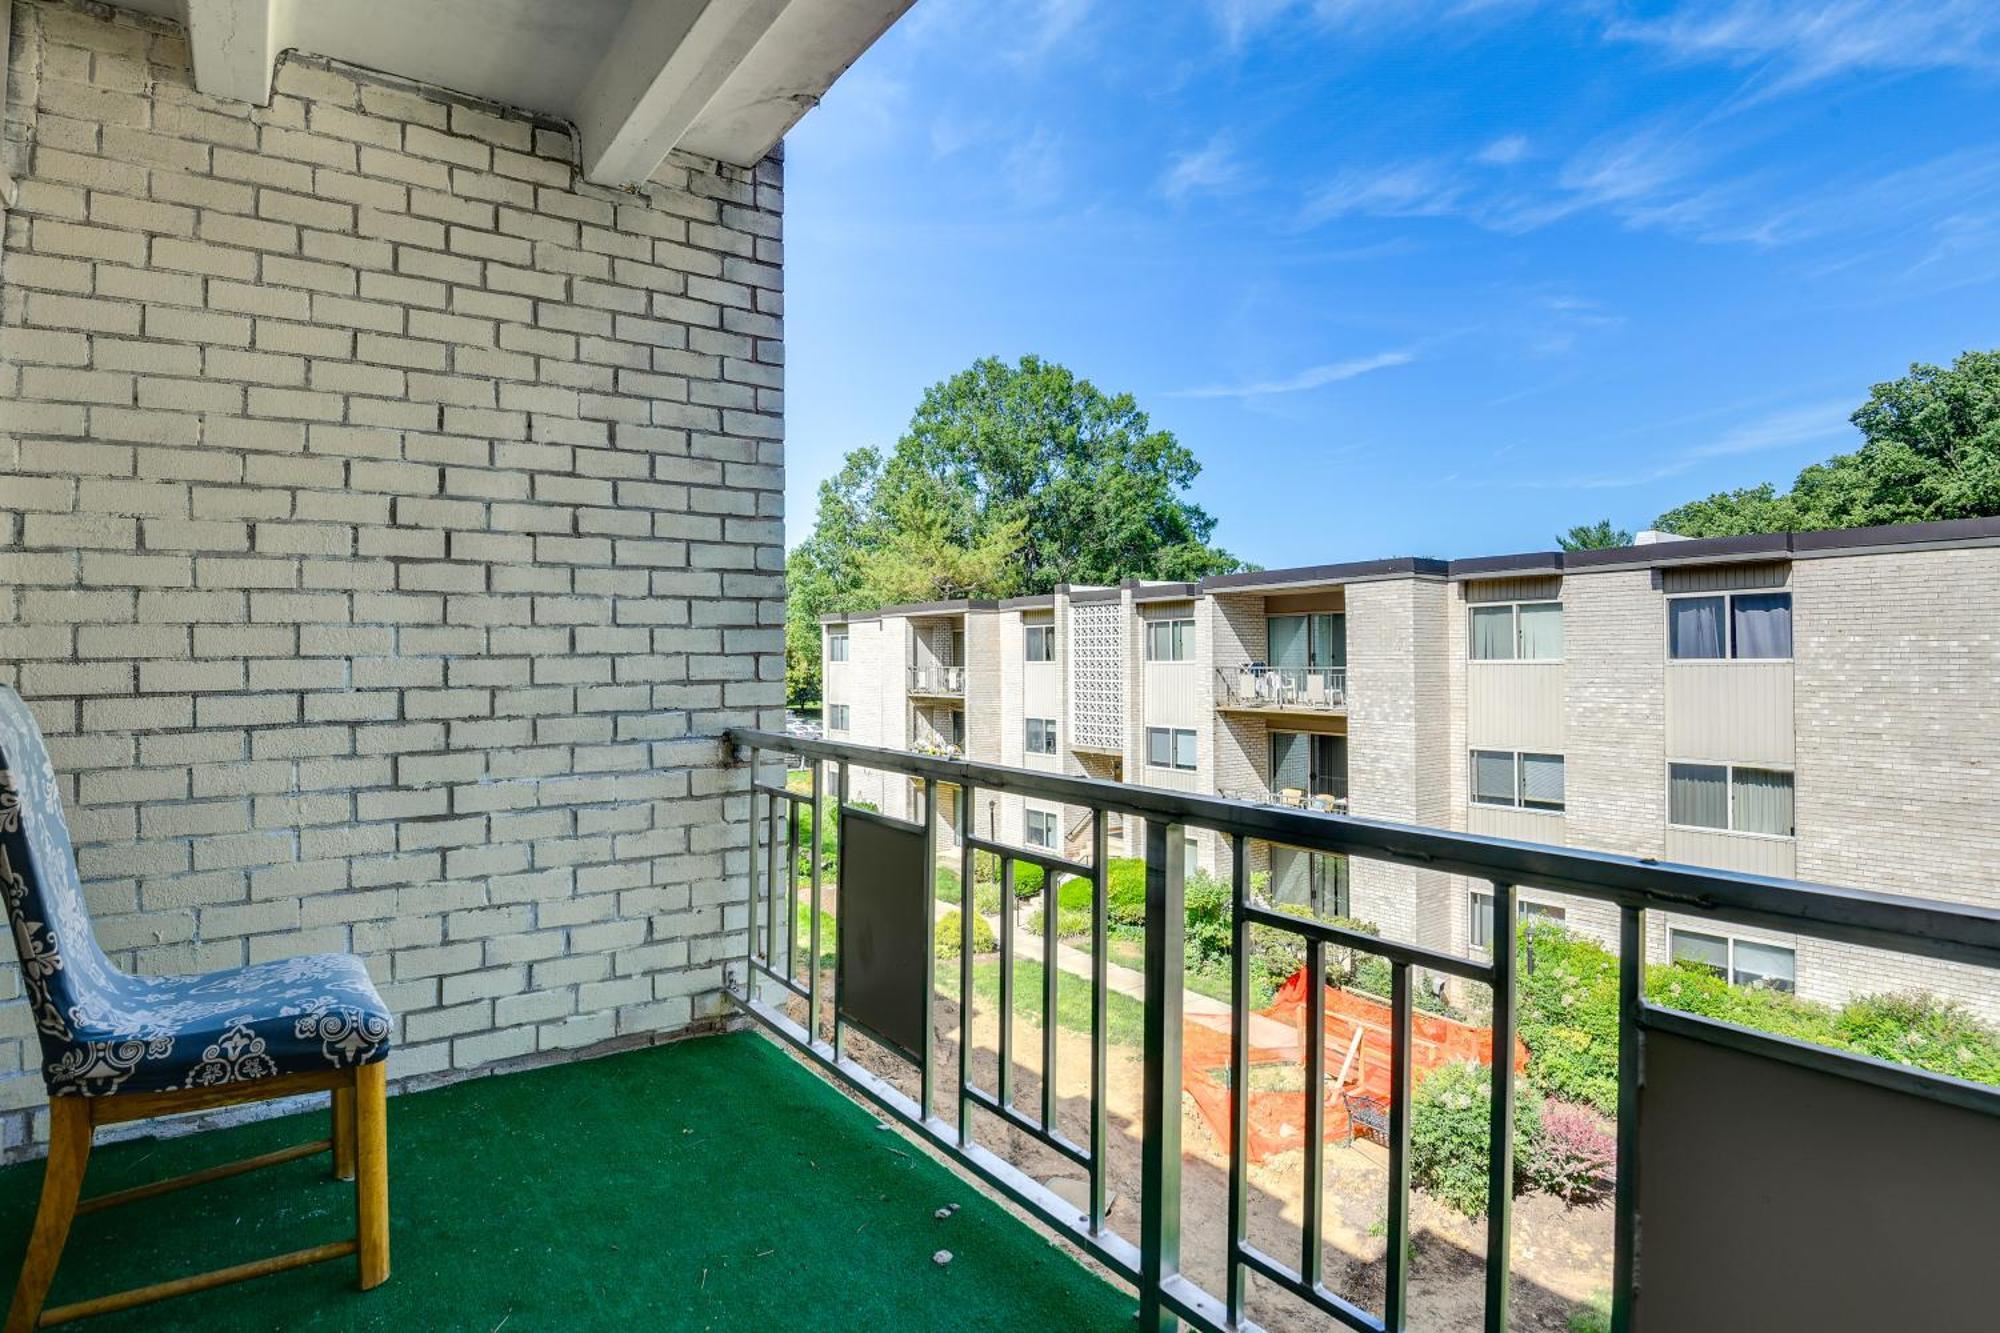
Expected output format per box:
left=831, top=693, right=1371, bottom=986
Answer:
left=44, top=953, right=390, bottom=1097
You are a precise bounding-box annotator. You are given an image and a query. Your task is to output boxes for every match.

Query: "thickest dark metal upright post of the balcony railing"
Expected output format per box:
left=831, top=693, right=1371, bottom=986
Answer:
left=1138, top=819, right=1188, bottom=1333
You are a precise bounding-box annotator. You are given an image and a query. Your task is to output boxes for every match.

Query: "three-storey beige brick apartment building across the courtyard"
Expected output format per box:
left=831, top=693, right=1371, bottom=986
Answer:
left=824, top=518, right=2000, bottom=1013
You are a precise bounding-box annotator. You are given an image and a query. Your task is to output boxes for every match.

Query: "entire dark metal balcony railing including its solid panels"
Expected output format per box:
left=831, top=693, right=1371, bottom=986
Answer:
left=728, top=731, right=2000, bottom=1333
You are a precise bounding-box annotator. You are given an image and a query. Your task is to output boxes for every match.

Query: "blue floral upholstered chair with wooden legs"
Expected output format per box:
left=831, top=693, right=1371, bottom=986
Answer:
left=0, top=685, right=392, bottom=1333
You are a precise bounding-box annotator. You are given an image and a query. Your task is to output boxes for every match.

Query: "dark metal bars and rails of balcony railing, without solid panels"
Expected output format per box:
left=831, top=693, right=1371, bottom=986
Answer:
left=726, top=729, right=2000, bottom=1333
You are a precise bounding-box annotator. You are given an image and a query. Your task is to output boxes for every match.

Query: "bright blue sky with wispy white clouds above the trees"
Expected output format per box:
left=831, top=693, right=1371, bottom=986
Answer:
left=786, top=0, right=2000, bottom=566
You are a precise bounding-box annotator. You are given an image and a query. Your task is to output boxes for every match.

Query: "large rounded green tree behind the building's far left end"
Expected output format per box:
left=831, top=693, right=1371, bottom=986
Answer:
left=786, top=356, right=1244, bottom=701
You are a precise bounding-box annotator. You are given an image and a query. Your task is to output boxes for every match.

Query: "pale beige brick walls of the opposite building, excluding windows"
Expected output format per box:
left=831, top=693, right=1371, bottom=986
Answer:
left=824, top=534, right=2000, bottom=1015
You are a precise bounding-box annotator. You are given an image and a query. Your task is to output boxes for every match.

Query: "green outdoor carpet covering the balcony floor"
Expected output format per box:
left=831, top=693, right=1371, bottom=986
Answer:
left=0, top=1033, right=1134, bottom=1333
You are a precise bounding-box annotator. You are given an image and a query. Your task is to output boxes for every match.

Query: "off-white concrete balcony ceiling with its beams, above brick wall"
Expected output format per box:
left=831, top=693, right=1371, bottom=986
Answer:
left=118, top=0, right=914, bottom=186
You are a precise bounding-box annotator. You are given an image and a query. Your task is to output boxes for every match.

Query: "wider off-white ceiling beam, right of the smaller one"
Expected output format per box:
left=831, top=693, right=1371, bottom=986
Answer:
left=576, top=0, right=790, bottom=186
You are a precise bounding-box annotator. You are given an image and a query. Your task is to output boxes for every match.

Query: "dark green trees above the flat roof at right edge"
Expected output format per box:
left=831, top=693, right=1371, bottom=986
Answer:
left=1658, top=350, right=2000, bottom=536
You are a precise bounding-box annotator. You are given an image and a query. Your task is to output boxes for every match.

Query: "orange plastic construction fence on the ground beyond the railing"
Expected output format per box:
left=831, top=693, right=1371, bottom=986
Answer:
left=1180, top=969, right=1528, bottom=1163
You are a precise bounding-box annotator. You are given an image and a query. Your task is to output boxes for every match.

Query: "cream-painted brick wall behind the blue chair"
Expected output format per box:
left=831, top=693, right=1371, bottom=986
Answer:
left=0, top=2, right=784, bottom=1151
